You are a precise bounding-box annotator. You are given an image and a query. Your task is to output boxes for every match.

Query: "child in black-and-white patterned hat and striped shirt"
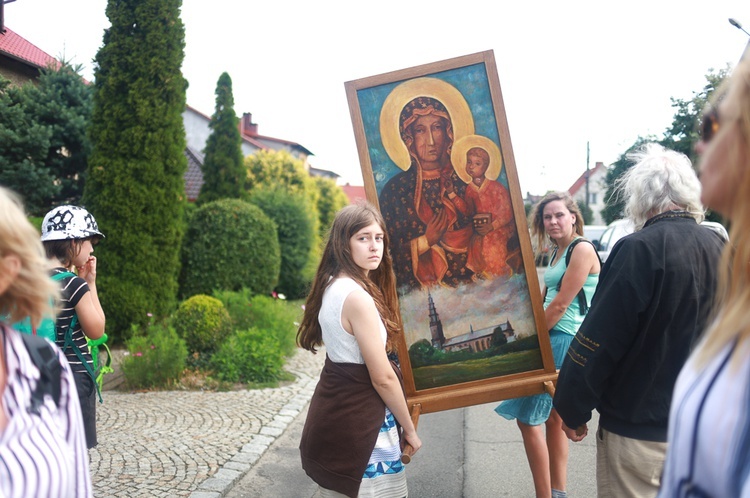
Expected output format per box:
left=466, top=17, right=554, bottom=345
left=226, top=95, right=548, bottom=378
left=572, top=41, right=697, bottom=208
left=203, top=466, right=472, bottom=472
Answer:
left=42, top=205, right=105, bottom=448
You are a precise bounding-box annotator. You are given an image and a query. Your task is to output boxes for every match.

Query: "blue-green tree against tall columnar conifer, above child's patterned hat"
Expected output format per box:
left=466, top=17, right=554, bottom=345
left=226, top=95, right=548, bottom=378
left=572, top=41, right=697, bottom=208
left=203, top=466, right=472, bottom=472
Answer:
left=24, top=62, right=92, bottom=210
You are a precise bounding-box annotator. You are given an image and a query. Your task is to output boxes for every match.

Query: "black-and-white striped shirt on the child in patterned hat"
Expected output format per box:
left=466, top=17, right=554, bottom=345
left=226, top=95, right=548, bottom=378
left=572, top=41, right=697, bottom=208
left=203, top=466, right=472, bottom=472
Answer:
left=52, top=268, right=93, bottom=372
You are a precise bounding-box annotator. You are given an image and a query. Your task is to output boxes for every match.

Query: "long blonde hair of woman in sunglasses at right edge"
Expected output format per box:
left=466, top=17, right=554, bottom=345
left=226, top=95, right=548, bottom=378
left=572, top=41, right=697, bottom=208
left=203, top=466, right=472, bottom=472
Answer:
left=696, top=59, right=750, bottom=366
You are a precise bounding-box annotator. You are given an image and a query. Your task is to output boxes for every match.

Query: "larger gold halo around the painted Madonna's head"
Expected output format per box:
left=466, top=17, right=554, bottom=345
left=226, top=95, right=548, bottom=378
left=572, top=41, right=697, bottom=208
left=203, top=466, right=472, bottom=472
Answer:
left=380, top=78, right=474, bottom=171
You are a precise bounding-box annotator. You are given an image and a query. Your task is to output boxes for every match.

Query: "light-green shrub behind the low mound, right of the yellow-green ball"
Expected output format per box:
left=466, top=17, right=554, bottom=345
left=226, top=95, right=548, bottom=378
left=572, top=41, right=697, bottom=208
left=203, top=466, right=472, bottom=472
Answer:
left=214, top=289, right=300, bottom=356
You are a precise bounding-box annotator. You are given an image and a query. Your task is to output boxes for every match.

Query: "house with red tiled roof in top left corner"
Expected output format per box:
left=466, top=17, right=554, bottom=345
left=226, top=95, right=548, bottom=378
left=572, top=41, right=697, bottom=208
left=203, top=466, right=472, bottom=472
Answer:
left=0, top=25, right=60, bottom=86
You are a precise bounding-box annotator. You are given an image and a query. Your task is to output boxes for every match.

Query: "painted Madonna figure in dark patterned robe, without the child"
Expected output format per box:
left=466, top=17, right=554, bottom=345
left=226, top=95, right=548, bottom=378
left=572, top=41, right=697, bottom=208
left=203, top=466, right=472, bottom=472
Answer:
left=379, top=96, right=474, bottom=292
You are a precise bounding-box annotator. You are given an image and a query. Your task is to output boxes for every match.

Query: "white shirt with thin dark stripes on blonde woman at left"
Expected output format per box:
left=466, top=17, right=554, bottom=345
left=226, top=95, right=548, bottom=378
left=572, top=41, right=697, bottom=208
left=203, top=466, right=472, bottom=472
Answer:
left=0, top=324, right=92, bottom=498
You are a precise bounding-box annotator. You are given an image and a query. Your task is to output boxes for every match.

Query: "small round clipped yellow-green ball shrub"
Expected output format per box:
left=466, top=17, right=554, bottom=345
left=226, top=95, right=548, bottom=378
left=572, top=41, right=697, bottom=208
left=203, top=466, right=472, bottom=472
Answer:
left=172, top=294, right=232, bottom=354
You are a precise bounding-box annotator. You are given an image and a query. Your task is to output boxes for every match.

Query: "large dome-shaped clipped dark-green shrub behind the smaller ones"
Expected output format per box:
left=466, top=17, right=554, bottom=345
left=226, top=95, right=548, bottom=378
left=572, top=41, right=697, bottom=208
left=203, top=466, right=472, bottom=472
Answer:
left=180, top=199, right=281, bottom=297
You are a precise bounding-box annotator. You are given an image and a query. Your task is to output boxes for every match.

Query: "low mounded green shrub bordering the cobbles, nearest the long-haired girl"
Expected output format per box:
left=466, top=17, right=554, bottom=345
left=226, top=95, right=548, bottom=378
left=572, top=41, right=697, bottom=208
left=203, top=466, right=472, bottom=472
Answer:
left=210, top=327, right=284, bottom=382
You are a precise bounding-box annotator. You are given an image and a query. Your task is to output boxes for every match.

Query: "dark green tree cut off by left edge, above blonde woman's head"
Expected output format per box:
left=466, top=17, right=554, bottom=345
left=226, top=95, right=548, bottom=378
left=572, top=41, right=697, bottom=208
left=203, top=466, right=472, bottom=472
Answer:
left=0, top=77, right=54, bottom=214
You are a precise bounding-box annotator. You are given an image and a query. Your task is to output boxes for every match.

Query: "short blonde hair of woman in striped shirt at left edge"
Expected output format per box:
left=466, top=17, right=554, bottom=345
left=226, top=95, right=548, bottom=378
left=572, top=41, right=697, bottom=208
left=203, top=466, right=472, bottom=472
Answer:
left=0, top=186, right=59, bottom=327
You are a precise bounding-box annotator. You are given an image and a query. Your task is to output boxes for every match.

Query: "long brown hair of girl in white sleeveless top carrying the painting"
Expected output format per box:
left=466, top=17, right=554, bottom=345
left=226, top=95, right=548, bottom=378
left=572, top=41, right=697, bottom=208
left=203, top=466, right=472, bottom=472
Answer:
left=297, top=203, right=403, bottom=353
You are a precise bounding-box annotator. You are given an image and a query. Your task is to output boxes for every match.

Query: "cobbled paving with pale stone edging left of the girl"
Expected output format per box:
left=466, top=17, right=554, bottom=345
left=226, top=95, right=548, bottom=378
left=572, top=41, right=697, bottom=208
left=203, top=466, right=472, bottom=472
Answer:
left=89, top=350, right=325, bottom=498
